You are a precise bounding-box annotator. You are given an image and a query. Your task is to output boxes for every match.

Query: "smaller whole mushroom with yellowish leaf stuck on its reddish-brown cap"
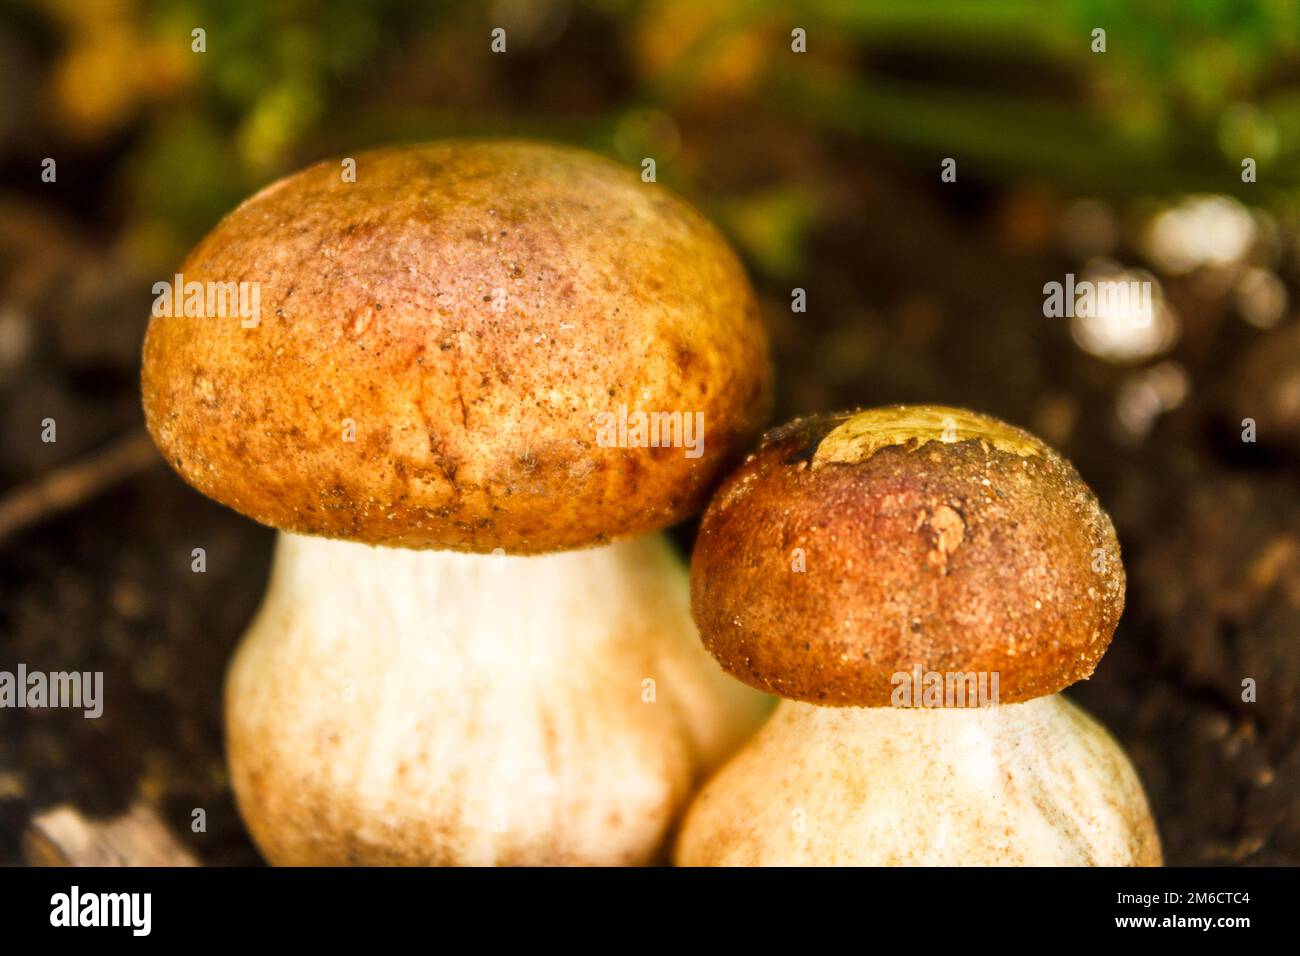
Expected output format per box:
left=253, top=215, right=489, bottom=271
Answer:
left=675, top=406, right=1161, bottom=866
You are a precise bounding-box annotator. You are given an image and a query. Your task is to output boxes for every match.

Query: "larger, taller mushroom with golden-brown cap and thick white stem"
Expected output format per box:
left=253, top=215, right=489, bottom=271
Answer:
left=143, top=140, right=770, bottom=865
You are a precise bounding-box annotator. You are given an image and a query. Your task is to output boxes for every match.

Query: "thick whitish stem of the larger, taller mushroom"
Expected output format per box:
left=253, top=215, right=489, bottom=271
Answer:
left=226, top=533, right=768, bottom=865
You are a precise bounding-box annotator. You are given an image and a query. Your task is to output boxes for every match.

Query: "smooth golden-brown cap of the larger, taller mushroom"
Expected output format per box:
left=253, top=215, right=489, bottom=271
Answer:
left=142, top=142, right=771, bottom=553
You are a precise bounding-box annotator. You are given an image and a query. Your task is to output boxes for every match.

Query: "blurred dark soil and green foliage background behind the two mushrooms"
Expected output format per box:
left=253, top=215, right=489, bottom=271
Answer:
left=0, top=0, right=1300, bottom=865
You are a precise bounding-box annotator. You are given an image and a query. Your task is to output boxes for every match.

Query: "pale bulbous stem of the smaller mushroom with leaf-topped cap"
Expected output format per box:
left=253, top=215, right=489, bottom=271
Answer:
left=676, top=695, right=1160, bottom=866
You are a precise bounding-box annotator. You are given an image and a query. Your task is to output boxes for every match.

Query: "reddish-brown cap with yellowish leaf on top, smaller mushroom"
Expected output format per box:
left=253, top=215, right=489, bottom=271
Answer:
left=690, top=406, right=1125, bottom=706
